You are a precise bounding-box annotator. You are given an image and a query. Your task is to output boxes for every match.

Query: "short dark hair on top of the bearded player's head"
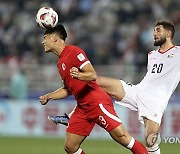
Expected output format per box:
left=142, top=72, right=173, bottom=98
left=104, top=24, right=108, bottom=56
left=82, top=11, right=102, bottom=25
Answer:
left=155, top=20, right=175, bottom=38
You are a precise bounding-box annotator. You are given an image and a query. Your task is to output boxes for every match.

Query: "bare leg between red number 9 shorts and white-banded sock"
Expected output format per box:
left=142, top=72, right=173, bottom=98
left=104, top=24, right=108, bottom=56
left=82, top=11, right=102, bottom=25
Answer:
left=109, top=124, right=132, bottom=146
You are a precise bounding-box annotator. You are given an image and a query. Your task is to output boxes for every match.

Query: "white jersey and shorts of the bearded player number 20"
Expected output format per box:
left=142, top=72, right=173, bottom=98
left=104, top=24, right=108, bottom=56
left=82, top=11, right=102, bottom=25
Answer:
left=115, top=46, right=180, bottom=124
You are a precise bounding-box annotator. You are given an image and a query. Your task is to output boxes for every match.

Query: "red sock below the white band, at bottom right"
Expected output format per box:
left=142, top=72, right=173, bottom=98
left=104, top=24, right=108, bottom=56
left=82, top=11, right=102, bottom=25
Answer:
left=131, top=140, right=148, bottom=154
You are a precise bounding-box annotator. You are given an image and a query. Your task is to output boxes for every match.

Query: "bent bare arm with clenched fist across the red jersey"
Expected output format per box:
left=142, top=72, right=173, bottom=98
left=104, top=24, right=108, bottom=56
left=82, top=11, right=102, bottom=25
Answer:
left=70, top=63, right=97, bottom=81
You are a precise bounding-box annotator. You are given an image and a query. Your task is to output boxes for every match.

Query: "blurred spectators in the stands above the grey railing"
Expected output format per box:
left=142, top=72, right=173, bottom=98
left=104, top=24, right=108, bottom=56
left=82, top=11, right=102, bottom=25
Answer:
left=0, top=0, right=180, bottom=71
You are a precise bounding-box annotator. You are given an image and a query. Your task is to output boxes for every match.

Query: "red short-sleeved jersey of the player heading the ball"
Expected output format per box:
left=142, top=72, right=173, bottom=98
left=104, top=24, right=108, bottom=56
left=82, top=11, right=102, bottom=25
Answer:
left=57, top=45, right=111, bottom=106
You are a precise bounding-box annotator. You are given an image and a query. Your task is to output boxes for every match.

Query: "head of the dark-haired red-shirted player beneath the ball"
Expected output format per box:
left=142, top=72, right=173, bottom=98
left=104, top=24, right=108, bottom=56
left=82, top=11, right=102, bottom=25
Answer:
left=42, top=24, right=67, bottom=52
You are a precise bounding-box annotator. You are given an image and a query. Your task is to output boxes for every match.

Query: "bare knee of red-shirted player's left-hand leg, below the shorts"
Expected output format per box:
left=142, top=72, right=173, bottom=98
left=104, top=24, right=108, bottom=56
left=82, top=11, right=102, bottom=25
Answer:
left=64, top=132, right=86, bottom=152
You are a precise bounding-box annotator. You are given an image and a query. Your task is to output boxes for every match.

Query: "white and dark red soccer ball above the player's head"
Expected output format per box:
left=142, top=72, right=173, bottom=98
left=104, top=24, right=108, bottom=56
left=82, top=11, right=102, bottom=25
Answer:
left=36, top=7, right=58, bottom=29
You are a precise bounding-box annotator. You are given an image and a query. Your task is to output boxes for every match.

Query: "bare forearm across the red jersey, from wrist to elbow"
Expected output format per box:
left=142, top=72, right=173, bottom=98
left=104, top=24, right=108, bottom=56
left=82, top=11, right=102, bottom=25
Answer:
left=77, top=72, right=97, bottom=81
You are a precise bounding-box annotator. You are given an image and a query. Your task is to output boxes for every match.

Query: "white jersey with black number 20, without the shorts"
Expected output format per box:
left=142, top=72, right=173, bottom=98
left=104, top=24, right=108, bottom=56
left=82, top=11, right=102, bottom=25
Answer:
left=137, top=46, right=180, bottom=109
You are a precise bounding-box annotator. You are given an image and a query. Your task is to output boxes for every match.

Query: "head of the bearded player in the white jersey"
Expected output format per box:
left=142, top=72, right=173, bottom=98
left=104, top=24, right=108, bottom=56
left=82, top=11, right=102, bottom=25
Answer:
left=153, top=20, right=175, bottom=46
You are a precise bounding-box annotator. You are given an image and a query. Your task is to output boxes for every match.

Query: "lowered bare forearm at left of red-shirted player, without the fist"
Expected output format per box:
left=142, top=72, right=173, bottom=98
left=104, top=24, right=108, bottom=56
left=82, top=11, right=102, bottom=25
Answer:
left=46, top=87, right=70, bottom=100
